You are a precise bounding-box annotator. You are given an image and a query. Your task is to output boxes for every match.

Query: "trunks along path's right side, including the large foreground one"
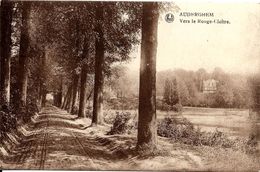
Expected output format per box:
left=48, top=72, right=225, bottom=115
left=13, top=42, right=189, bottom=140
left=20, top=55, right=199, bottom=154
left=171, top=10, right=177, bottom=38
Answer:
left=58, top=2, right=159, bottom=152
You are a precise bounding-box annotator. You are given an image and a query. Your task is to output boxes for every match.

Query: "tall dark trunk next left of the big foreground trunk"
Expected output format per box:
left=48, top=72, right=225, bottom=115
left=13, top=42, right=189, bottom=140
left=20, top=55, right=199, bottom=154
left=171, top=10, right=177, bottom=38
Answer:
left=92, top=4, right=105, bottom=125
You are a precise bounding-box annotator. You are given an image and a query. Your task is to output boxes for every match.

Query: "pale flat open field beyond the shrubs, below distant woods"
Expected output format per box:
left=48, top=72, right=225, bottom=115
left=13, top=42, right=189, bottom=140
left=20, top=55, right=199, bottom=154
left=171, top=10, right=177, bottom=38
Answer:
left=105, top=107, right=258, bottom=136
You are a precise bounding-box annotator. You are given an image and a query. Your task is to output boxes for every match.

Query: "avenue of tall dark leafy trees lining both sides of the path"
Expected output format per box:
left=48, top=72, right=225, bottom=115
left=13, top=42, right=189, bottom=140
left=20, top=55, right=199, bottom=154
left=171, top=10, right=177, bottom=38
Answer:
left=0, top=0, right=175, bottom=149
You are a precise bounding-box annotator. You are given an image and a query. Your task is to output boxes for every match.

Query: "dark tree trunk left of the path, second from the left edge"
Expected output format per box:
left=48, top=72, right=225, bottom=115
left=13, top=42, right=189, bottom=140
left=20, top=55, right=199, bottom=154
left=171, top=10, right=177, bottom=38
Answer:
left=18, top=1, right=31, bottom=107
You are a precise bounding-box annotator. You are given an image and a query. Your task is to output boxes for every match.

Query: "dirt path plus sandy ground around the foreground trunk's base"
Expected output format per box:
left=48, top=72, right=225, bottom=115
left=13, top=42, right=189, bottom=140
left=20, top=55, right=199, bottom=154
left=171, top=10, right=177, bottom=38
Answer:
left=0, top=107, right=209, bottom=170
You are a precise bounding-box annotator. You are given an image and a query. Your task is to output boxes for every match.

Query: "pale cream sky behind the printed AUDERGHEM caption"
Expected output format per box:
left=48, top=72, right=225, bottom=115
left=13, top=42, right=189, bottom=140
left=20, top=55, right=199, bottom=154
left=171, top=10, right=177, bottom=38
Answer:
left=127, top=2, right=260, bottom=74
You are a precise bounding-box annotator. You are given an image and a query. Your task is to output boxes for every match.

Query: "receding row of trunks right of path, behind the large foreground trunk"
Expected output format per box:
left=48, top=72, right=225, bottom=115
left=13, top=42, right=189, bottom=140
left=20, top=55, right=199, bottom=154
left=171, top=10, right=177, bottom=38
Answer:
left=59, top=3, right=105, bottom=122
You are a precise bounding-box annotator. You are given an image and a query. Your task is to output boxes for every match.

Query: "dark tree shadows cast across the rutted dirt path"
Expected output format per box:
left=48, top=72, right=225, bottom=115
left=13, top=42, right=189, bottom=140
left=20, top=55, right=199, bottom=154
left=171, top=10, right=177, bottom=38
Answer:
left=2, top=107, right=137, bottom=169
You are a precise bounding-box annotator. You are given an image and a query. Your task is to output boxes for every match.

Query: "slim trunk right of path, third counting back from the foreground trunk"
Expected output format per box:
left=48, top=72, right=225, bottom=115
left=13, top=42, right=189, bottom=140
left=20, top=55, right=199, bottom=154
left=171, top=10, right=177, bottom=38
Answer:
left=78, top=64, right=88, bottom=118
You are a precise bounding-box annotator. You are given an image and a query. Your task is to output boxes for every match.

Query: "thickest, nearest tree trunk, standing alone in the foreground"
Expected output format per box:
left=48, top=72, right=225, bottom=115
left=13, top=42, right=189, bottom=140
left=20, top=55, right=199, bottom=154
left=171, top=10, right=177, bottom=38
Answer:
left=137, top=2, right=159, bottom=150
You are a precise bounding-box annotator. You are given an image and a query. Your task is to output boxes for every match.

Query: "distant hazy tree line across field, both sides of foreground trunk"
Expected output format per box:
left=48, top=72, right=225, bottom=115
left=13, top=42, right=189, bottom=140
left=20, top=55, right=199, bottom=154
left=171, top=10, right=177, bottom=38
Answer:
left=105, top=66, right=257, bottom=110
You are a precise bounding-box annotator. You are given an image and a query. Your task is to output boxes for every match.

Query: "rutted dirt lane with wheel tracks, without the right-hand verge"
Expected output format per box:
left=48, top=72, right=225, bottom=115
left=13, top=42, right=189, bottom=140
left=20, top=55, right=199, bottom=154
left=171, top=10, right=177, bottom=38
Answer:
left=3, top=107, right=95, bottom=169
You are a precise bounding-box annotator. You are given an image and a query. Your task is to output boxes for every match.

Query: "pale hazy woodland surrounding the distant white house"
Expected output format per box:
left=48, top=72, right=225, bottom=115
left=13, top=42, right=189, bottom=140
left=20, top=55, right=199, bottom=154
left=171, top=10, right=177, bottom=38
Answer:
left=157, top=68, right=254, bottom=108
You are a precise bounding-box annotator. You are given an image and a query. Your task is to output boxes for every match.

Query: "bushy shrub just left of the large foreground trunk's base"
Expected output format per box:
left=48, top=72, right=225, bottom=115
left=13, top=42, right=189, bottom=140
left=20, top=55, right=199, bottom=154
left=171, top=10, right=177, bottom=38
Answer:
left=107, top=112, right=137, bottom=135
